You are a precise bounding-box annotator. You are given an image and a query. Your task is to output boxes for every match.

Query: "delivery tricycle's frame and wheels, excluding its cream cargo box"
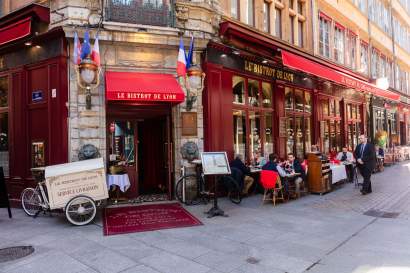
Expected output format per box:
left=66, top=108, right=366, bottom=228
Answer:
left=21, top=168, right=101, bottom=226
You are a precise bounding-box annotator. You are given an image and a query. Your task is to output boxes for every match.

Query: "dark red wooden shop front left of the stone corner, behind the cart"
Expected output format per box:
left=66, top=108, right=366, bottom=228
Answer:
left=0, top=4, right=68, bottom=202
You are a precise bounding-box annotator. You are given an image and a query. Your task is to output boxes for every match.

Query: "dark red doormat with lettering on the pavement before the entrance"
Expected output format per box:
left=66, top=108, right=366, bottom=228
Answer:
left=103, top=203, right=202, bottom=236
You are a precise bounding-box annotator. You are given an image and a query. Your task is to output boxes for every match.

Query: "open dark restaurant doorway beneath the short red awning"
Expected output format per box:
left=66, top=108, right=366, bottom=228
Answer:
left=107, top=105, right=173, bottom=199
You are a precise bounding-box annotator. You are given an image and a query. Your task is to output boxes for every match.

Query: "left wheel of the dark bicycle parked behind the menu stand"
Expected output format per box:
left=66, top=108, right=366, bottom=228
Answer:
left=175, top=174, right=201, bottom=205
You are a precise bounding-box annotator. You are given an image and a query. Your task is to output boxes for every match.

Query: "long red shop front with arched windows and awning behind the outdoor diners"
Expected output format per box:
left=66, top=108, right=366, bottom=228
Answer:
left=204, top=21, right=399, bottom=164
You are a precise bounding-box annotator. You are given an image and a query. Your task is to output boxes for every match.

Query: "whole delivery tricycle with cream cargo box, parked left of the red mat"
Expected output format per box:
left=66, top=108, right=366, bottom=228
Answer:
left=21, top=158, right=108, bottom=226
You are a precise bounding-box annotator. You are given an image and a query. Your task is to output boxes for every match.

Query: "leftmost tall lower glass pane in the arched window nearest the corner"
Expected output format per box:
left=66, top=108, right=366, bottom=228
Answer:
left=233, top=110, right=246, bottom=160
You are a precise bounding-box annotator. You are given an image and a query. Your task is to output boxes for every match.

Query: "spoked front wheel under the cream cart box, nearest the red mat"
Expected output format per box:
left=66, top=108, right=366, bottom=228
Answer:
left=65, top=195, right=97, bottom=226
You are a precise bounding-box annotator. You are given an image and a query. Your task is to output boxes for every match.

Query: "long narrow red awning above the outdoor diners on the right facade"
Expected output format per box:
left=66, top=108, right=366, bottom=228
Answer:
left=282, top=50, right=400, bottom=101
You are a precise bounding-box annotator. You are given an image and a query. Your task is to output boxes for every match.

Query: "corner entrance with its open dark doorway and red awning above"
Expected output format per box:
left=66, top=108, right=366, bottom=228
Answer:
left=105, top=71, right=185, bottom=199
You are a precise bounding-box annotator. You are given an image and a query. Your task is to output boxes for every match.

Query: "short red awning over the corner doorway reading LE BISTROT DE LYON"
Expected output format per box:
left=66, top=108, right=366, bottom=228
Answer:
left=105, top=71, right=185, bottom=103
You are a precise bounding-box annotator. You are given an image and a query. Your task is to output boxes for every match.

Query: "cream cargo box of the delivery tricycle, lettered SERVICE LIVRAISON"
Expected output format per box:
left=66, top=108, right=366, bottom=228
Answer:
left=45, top=158, right=108, bottom=209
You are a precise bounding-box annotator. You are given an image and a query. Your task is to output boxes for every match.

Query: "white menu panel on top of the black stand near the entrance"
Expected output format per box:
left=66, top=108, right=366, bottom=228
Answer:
left=201, top=152, right=231, bottom=175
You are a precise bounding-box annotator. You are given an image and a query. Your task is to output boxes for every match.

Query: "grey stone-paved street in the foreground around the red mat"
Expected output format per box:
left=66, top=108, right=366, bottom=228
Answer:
left=0, top=162, right=410, bottom=273
